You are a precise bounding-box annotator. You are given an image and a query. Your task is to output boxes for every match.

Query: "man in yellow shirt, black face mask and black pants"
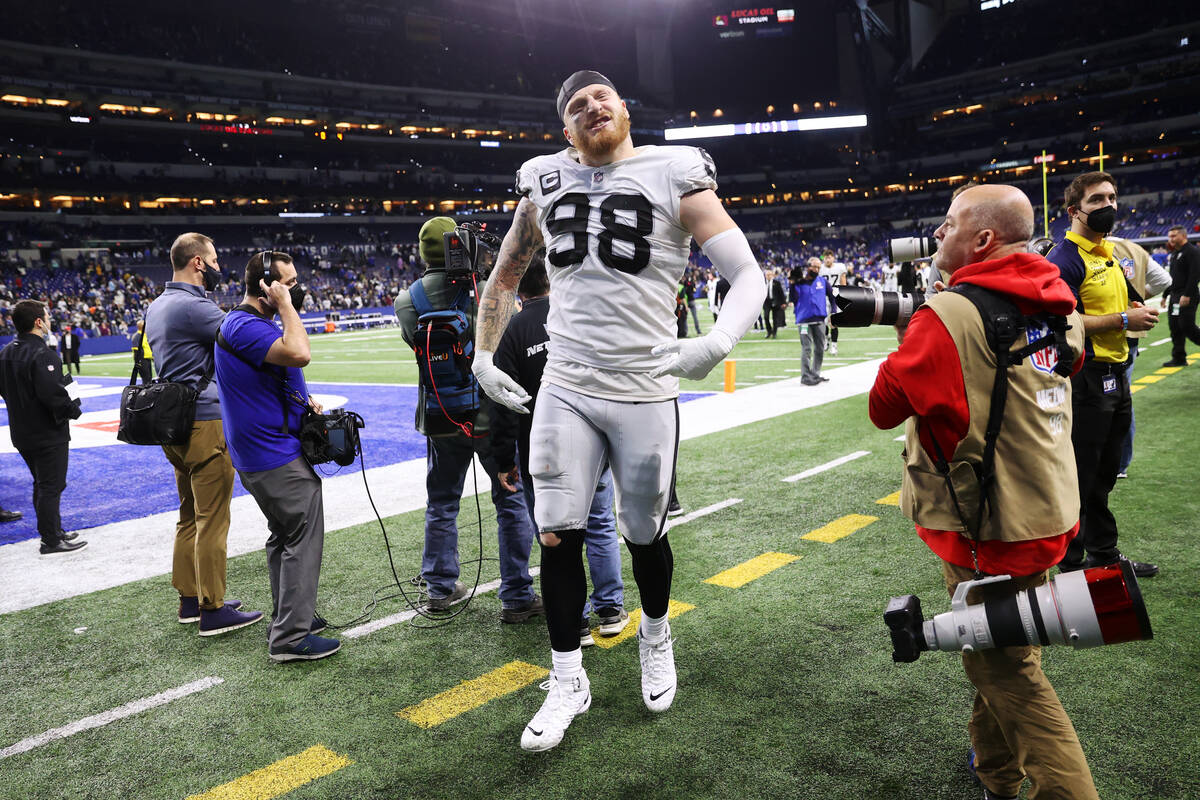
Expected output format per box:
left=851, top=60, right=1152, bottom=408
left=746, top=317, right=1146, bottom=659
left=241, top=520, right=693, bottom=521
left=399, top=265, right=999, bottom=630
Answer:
left=1046, top=173, right=1158, bottom=578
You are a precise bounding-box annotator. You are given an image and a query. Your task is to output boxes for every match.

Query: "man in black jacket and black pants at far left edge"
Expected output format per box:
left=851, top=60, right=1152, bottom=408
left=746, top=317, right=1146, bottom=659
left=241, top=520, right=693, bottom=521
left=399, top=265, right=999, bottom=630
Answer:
left=0, top=300, right=88, bottom=555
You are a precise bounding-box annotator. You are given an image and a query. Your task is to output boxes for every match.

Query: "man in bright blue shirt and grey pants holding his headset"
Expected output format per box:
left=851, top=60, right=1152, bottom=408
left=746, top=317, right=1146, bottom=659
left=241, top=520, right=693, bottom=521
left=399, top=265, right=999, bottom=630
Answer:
left=216, top=251, right=341, bottom=661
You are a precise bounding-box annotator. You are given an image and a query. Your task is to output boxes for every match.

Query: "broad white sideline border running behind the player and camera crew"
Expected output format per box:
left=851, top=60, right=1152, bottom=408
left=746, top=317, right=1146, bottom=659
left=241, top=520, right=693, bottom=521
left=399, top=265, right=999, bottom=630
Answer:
left=0, top=360, right=881, bottom=614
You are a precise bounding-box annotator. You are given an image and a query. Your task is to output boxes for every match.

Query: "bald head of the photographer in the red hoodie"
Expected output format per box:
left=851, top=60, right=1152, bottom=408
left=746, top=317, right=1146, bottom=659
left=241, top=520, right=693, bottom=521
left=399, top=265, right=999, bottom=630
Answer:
left=934, top=184, right=1033, bottom=272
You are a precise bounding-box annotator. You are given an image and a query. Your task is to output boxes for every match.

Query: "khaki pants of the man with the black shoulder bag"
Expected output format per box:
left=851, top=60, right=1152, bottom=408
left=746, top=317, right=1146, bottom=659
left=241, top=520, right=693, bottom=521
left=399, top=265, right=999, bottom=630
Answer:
left=162, top=420, right=233, bottom=610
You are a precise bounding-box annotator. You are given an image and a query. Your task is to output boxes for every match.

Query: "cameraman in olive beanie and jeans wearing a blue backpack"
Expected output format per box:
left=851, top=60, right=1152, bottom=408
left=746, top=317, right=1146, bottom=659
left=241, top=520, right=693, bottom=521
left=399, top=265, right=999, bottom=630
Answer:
left=396, top=217, right=535, bottom=622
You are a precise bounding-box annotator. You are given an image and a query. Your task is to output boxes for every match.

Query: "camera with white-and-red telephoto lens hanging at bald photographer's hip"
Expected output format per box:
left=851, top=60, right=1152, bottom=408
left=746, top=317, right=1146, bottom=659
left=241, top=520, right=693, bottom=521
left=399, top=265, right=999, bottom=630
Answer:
left=883, top=560, right=1154, bottom=662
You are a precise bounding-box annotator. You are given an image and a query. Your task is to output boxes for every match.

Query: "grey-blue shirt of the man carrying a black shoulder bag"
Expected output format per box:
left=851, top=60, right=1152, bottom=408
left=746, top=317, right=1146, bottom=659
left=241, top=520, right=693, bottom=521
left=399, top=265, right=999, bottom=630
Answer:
left=145, top=281, right=224, bottom=420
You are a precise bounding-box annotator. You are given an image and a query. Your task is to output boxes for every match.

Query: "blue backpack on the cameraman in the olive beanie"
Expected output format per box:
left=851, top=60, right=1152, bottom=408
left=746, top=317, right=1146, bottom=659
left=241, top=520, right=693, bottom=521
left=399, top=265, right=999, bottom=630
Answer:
left=408, top=281, right=479, bottom=437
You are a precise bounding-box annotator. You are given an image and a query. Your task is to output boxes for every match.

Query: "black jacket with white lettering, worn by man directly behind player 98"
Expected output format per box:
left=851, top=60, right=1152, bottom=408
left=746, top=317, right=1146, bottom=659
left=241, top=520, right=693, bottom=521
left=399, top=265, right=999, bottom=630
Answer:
left=491, top=296, right=550, bottom=476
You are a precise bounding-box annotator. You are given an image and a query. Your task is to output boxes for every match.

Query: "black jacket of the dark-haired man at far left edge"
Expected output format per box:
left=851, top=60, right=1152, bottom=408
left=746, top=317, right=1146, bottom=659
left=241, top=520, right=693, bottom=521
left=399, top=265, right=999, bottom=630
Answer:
left=0, top=333, right=83, bottom=450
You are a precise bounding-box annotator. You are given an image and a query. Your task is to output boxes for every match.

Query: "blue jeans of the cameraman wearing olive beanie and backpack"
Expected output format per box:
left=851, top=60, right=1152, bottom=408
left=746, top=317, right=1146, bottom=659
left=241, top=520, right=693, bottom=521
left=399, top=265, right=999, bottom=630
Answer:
left=421, top=435, right=534, bottom=607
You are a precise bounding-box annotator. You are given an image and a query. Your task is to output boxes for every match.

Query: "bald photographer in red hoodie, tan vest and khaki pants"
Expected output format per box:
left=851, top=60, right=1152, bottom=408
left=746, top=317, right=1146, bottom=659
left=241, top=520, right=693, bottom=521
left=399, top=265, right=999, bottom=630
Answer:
left=870, top=185, right=1098, bottom=800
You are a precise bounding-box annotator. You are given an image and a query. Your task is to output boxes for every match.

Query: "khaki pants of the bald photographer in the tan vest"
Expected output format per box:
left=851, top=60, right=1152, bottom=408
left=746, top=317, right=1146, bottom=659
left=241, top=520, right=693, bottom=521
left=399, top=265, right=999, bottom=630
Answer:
left=942, top=561, right=1099, bottom=800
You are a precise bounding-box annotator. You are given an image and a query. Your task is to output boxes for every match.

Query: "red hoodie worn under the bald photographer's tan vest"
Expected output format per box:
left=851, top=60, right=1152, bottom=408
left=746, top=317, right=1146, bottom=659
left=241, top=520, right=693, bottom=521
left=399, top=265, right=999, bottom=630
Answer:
left=870, top=253, right=1082, bottom=576
